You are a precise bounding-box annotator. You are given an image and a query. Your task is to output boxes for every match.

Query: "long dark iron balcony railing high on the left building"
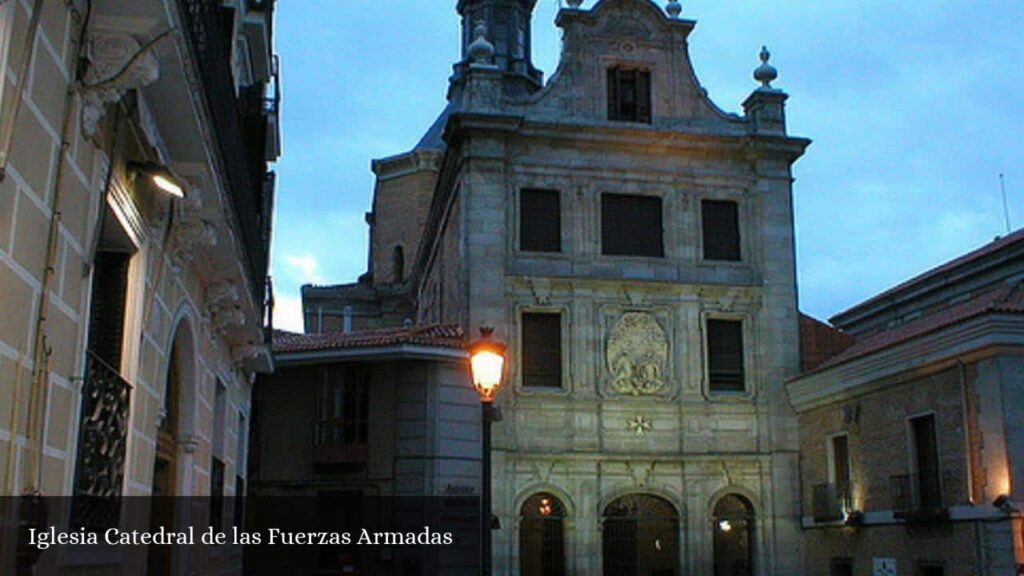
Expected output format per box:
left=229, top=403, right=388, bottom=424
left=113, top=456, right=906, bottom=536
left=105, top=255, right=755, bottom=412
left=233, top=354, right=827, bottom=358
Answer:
left=178, top=0, right=270, bottom=302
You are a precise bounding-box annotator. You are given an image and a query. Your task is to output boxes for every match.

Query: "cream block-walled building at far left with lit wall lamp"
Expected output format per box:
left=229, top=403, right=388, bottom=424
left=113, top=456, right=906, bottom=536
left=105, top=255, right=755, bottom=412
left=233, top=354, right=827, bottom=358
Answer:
left=0, top=0, right=280, bottom=575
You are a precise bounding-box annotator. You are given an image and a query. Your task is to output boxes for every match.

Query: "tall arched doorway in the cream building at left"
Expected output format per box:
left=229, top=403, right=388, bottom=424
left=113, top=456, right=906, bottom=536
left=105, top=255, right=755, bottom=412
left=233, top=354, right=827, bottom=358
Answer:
left=146, top=322, right=195, bottom=576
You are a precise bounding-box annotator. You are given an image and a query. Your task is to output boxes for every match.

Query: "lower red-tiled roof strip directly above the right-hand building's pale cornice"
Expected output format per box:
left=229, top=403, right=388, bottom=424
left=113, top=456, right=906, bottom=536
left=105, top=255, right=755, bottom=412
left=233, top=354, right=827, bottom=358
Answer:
left=808, top=283, right=1024, bottom=374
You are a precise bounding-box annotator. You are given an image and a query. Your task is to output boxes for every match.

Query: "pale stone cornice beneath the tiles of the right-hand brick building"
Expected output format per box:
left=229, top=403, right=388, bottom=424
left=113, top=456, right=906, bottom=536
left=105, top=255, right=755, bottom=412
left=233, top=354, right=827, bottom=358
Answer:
left=785, top=314, right=1024, bottom=413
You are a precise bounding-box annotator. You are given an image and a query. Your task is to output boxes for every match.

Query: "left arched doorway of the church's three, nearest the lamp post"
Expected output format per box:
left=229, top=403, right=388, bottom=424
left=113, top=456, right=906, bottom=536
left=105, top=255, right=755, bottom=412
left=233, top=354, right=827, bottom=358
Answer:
left=519, top=493, right=565, bottom=576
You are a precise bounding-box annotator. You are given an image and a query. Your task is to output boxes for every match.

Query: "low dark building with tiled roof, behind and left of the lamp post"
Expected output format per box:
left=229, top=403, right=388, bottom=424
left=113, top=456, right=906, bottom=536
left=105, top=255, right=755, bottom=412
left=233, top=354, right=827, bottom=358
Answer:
left=253, top=325, right=480, bottom=575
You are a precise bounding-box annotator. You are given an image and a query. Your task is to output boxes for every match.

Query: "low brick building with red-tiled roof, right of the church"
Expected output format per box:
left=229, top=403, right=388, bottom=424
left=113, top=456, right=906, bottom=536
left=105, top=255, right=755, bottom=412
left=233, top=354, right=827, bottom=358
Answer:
left=786, top=232, right=1024, bottom=576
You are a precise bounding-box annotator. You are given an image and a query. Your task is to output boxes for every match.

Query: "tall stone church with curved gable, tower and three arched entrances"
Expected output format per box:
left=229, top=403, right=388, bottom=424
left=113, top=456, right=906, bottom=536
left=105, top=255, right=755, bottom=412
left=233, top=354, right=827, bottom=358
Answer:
left=292, top=0, right=809, bottom=575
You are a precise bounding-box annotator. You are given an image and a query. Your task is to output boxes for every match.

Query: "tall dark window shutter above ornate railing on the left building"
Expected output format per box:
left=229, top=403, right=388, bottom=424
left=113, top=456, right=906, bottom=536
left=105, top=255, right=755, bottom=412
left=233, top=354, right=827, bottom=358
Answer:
left=89, top=252, right=131, bottom=370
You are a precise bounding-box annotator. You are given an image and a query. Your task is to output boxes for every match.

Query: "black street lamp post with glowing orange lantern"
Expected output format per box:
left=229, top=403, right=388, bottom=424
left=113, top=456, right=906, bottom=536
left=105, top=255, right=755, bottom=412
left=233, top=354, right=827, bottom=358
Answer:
left=469, top=326, right=508, bottom=576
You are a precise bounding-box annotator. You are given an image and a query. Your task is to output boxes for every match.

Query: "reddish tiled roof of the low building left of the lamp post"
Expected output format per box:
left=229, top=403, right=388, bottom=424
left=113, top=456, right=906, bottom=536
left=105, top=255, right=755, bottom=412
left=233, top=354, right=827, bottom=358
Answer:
left=273, top=324, right=465, bottom=354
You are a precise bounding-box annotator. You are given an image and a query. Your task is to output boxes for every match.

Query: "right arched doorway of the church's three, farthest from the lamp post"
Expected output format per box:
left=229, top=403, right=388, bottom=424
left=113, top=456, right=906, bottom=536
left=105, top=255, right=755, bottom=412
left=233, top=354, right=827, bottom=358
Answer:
left=712, top=494, right=756, bottom=576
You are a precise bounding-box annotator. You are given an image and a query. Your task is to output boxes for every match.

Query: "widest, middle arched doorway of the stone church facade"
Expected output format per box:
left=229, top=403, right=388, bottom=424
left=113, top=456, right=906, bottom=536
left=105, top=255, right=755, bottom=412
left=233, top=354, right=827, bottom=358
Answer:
left=602, top=494, right=679, bottom=576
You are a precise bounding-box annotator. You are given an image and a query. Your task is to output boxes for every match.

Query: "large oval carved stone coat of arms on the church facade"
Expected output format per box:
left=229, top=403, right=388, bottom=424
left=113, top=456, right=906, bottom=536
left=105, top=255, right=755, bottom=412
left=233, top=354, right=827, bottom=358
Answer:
left=607, top=312, right=669, bottom=396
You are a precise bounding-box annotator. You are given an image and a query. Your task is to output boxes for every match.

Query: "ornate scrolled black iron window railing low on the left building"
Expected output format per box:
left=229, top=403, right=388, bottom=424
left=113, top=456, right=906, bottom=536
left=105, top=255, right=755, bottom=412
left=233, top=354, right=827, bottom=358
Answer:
left=72, top=352, right=131, bottom=529
